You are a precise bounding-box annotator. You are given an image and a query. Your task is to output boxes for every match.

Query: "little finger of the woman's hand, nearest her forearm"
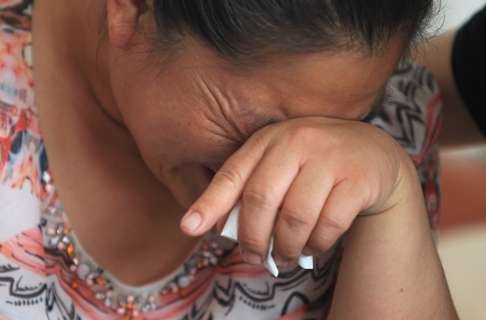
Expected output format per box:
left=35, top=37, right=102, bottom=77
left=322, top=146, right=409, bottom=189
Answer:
left=307, top=180, right=364, bottom=252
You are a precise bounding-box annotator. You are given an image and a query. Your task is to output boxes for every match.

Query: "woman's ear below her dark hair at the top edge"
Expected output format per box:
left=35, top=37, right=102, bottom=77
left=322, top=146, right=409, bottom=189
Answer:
left=107, top=0, right=147, bottom=49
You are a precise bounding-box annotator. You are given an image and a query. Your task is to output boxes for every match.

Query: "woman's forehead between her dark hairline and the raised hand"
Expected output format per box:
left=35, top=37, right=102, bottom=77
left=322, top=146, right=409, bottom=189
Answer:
left=222, top=38, right=406, bottom=119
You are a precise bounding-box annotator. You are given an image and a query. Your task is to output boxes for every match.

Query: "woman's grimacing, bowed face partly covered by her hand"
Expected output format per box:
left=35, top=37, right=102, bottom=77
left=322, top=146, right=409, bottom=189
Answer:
left=109, top=31, right=404, bottom=207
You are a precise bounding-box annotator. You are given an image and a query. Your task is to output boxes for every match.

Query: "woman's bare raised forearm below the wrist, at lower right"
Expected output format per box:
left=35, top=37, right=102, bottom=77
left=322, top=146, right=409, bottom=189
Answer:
left=328, top=164, right=457, bottom=320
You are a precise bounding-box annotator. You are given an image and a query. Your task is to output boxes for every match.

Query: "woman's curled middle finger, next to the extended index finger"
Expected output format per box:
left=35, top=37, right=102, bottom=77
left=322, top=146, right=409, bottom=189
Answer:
left=238, top=146, right=300, bottom=264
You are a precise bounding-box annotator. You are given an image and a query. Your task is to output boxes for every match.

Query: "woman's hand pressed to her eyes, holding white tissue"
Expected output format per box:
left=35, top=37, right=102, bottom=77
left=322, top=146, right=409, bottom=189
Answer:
left=181, top=118, right=410, bottom=267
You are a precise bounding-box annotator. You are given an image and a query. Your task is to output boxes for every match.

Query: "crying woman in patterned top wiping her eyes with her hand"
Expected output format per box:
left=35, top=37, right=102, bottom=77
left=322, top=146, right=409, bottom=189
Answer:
left=0, top=0, right=456, bottom=319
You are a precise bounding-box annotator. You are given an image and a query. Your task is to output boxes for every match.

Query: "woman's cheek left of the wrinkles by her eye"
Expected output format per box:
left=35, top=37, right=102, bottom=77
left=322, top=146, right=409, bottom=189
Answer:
left=108, top=64, right=238, bottom=172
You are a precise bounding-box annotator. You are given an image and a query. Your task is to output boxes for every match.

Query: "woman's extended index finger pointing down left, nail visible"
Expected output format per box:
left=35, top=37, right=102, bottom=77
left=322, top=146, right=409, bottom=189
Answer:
left=181, top=131, right=267, bottom=236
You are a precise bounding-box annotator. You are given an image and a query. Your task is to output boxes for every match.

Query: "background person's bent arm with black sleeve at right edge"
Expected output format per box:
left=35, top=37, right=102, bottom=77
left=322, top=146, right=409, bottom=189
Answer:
left=417, top=7, right=486, bottom=146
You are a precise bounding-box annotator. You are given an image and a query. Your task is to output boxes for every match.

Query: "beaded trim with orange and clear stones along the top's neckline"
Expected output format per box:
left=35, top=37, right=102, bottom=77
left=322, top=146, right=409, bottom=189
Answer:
left=40, top=172, right=225, bottom=317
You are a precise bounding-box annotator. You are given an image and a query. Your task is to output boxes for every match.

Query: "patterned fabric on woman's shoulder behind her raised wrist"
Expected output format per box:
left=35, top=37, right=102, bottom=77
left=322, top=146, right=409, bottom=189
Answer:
left=368, top=63, right=442, bottom=229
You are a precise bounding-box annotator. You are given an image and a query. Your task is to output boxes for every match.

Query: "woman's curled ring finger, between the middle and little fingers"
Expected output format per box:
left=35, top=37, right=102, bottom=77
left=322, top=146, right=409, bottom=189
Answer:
left=273, top=165, right=334, bottom=267
